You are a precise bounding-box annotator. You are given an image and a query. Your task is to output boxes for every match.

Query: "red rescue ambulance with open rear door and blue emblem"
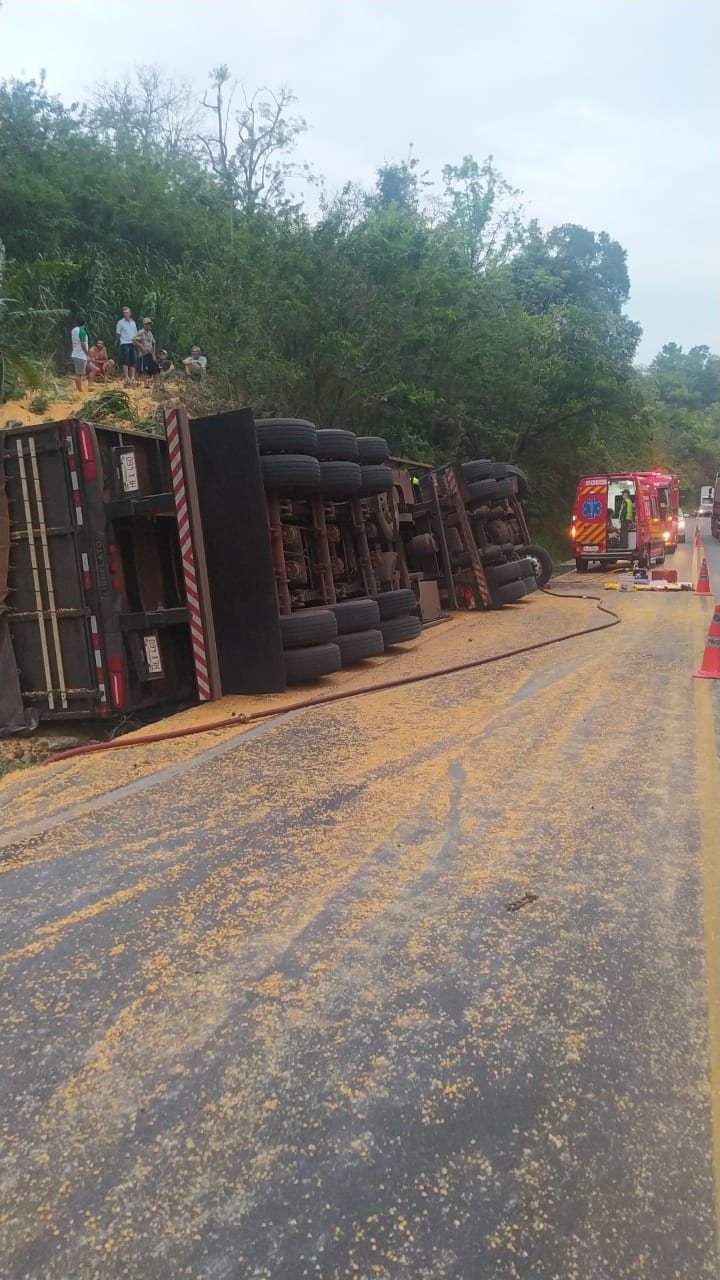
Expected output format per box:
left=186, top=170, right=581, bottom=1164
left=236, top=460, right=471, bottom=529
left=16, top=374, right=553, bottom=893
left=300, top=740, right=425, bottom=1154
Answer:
left=570, top=471, right=679, bottom=573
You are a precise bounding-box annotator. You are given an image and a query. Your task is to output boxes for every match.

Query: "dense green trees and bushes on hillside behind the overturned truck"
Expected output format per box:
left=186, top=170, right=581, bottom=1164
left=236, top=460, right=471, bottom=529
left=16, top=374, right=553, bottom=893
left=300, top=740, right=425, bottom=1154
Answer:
left=0, top=68, right=720, bottom=532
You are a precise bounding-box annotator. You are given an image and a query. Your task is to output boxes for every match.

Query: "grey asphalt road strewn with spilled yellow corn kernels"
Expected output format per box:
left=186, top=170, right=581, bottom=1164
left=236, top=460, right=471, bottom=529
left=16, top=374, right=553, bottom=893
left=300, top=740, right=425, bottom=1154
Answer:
left=0, top=522, right=720, bottom=1280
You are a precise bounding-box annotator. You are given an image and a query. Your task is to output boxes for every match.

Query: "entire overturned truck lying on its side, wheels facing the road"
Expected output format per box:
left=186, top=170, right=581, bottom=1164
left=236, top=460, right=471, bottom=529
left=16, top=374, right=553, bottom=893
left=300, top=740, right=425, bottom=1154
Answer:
left=0, top=408, right=538, bottom=733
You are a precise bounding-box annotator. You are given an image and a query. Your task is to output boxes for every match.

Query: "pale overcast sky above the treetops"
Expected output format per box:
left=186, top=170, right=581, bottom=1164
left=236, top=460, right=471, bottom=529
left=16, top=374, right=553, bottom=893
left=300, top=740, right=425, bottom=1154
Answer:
left=0, top=0, right=720, bottom=361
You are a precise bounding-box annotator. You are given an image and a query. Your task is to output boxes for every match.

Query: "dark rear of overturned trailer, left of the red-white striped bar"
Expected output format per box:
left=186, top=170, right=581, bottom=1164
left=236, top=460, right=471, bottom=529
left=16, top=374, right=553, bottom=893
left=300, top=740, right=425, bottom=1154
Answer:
left=0, top=420, right=193, bottom=732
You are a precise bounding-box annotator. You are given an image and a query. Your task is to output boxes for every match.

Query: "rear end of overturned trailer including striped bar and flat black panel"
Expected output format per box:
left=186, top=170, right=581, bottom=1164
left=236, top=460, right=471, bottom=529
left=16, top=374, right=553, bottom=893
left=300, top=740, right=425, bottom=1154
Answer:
left=0, top=412, right=284, bottom=733
